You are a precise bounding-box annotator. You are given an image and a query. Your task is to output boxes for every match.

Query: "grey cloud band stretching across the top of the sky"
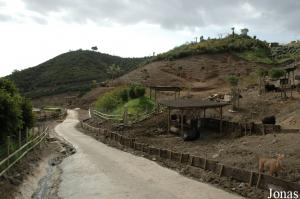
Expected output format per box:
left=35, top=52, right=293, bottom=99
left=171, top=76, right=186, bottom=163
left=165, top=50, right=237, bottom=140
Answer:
left=24, top=0, right=300, bottom=34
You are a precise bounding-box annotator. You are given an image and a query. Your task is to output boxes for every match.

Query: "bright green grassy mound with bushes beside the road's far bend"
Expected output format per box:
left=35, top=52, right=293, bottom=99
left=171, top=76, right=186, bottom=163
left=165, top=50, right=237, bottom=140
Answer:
left=95, top=85, right=154, bottom=119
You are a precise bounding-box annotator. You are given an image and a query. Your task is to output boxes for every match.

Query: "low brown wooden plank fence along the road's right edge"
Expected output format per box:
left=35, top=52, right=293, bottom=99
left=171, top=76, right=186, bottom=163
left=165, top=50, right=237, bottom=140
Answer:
left=81, top=121, right=300, bottom=191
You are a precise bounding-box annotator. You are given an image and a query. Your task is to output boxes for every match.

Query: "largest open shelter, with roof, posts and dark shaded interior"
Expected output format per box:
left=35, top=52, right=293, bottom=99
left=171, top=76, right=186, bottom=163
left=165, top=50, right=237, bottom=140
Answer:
left=160, top=99, right=228, bottom=141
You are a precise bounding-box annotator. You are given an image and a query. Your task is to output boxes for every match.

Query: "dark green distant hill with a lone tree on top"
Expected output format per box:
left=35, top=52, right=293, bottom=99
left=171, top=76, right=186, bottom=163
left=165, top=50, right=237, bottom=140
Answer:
left=8, top=50, right=146, bottom=98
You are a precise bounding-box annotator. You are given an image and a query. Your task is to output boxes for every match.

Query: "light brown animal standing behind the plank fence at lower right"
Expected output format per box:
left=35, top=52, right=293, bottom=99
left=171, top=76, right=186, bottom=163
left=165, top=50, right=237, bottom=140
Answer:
left=258, top=154, right=284, bottom=176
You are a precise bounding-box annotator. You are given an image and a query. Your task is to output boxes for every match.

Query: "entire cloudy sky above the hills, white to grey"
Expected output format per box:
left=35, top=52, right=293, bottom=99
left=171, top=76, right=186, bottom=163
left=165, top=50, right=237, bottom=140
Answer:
left=0, top=0, right=300, bottom=77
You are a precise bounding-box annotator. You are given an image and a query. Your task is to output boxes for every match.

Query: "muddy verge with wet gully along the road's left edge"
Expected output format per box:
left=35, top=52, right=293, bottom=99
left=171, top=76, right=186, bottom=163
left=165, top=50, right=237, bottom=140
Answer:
left=0, top=121, right=75, bottom=199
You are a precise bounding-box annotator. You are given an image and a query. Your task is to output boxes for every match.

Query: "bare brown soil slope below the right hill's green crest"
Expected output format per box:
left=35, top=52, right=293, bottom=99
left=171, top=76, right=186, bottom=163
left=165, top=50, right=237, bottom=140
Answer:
left=111, top=53, right=270, bottom=91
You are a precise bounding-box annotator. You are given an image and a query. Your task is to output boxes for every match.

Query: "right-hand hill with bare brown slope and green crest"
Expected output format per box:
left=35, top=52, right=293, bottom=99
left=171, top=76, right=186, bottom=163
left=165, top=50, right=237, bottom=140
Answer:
left=111, top=35, right=300, bottom=94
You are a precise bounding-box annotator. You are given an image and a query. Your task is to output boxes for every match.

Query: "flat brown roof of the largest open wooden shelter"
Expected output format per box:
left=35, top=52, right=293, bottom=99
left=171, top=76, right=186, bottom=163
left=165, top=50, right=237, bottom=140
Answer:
left=159, top=99, right=229, bottom=109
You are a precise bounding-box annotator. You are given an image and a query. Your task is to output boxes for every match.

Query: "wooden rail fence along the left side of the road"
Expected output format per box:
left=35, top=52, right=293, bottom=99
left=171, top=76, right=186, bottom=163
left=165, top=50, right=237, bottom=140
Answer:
left=0, top=127, right=49, bottom=177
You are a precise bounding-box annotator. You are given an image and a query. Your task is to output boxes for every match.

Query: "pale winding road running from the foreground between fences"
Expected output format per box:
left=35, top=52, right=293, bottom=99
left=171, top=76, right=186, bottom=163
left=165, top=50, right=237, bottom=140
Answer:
left=55, top=110, right=241, bottom=199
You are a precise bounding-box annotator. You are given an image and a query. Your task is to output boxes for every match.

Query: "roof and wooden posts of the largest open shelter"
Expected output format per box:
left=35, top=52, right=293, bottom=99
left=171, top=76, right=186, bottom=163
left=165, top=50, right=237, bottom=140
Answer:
left=160, top=99, right=229, bottom=134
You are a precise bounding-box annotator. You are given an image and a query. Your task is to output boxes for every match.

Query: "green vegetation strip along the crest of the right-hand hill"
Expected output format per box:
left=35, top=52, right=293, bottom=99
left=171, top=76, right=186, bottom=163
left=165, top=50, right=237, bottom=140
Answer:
left=152, top=35, right=300, bottom=64
